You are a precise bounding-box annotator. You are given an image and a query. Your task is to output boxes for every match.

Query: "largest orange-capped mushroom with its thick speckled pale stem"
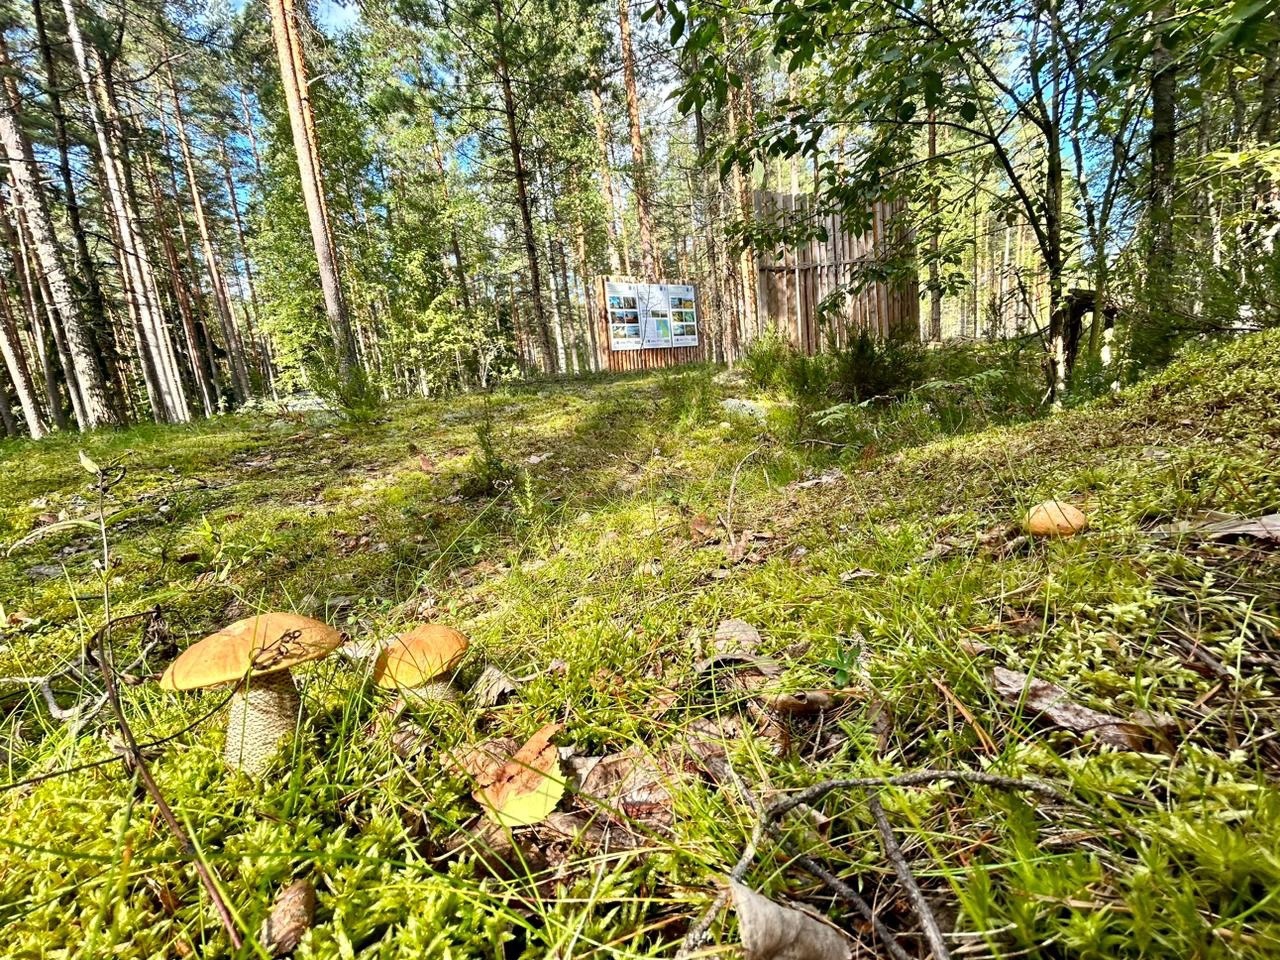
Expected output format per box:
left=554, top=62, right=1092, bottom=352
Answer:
left=160, top=613, right=342, bottom=776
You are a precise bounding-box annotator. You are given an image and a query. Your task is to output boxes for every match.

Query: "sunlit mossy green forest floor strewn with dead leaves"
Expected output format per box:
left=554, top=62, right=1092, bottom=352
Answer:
left=0, top=334, right=1280, bottom=959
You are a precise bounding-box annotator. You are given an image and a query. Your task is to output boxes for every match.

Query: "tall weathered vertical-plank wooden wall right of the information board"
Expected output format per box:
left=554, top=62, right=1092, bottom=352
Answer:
left=744, top=191, right=920, bottom=353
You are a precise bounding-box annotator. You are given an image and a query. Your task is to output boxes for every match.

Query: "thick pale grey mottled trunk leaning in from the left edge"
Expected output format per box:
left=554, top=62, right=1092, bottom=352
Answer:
left=0, top=37, right=120, bottom=429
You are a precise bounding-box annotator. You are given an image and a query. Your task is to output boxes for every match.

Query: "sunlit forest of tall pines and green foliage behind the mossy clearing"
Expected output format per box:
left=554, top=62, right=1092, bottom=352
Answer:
left=0, top=0, right=1280, bottom=436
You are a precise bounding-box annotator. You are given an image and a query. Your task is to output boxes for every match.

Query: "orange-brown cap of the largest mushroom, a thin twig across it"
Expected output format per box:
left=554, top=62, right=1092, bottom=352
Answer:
left=160, top=613, right=342, bottom=690
